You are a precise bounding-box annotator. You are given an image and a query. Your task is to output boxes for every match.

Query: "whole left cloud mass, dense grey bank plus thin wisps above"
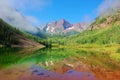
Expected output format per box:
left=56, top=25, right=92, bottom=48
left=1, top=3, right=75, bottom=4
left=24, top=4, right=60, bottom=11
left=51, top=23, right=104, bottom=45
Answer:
left=0, top=0, right=51, bottom=33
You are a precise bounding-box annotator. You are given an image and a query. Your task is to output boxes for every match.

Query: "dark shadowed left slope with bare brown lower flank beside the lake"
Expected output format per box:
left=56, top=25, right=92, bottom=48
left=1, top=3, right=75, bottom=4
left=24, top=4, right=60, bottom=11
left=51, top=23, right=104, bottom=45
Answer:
left=0, top=19, right=43, bottom=47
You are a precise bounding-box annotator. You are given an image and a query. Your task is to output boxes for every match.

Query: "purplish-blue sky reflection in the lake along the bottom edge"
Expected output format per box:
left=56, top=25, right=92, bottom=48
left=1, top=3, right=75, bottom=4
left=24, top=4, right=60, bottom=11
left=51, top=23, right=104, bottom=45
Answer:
left=20, top=65, right=97, bottom=80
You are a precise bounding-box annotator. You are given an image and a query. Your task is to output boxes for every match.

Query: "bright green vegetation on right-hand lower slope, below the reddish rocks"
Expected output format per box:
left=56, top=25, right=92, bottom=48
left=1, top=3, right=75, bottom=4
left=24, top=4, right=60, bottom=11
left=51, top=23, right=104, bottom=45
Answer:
left=47, top=24, right=120, bottom=45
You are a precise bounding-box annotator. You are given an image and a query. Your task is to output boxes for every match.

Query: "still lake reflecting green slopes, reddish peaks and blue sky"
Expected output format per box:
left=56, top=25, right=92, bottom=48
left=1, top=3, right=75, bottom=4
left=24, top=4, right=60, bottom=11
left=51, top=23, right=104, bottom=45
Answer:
left=0, top=48, right=119, bottom=80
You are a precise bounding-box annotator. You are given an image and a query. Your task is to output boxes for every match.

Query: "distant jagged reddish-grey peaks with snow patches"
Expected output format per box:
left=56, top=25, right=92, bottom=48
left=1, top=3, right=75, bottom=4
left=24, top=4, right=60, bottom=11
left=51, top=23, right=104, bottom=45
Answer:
left=40, top=19, right=87, bottom=34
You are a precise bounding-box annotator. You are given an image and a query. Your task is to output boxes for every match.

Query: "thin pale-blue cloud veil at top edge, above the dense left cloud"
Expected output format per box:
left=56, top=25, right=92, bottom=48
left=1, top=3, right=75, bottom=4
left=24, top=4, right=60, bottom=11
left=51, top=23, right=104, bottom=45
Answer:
left=12, top=0, right=52, bottom=12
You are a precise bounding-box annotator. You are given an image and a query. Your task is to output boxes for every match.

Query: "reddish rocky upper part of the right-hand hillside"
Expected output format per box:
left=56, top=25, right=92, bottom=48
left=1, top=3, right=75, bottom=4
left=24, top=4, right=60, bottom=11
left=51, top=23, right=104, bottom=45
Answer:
left=88, top=10, right=120, bottom=30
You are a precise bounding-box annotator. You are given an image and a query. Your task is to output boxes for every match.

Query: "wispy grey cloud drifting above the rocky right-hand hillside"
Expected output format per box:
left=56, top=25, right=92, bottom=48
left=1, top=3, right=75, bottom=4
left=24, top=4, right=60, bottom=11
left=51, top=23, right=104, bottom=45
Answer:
left=83, top=0, right=120, bottom=26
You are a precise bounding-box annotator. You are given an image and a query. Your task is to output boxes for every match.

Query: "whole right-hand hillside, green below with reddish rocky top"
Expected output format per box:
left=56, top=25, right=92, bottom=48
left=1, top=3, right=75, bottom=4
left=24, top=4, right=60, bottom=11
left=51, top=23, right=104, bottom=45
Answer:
left=66, top=11, right=120, bottom=44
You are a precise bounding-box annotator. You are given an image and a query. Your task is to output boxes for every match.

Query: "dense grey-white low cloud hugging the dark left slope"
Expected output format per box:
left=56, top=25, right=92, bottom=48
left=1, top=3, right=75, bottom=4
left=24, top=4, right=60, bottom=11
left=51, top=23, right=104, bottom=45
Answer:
left=0, top=8, right=37, bottom=33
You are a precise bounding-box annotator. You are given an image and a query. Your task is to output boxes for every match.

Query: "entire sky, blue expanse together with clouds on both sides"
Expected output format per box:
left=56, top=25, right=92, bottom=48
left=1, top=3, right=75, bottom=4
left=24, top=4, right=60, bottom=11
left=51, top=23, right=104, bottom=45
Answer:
left=0, top=0, right=120, bottom=32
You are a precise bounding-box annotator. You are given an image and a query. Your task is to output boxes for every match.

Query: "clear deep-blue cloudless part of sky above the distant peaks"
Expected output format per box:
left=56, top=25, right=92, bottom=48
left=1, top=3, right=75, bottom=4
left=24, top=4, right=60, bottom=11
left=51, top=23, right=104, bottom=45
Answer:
left=23, top=0, right=103, bottom=24
